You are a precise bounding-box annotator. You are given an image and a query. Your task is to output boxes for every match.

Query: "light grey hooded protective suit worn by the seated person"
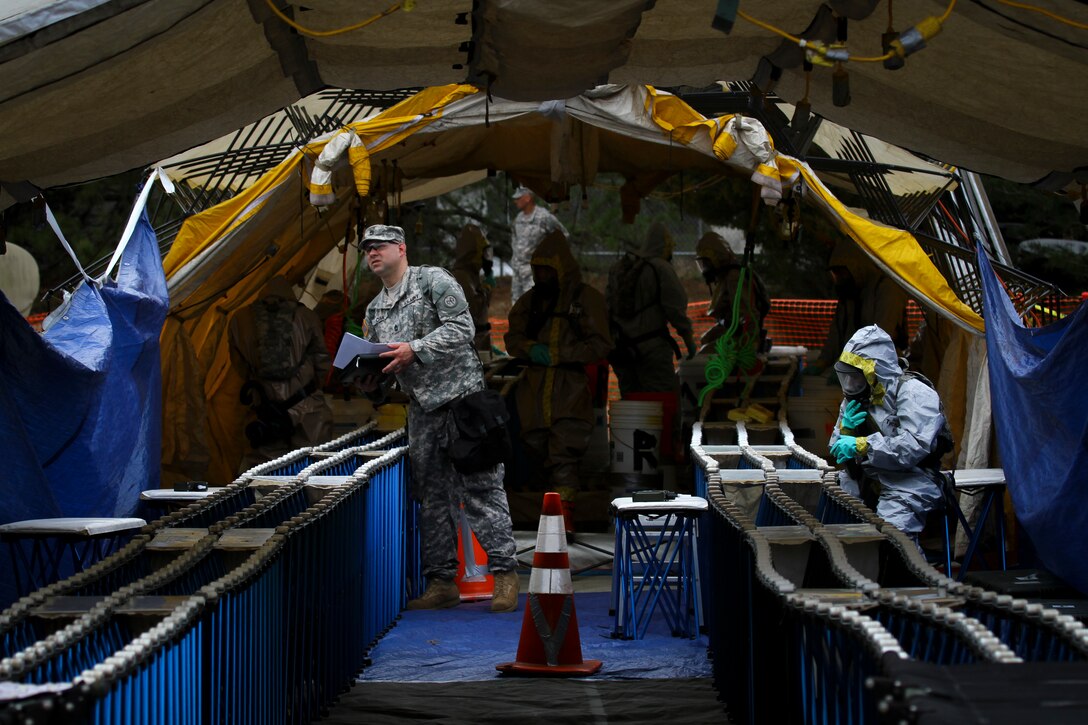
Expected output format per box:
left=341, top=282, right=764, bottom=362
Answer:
left=829, top=325, right=945, bottom=534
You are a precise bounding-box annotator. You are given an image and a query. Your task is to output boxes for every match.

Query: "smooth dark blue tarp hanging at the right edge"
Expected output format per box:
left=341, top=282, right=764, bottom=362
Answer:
left=978, top=246, right=1088, bottom=593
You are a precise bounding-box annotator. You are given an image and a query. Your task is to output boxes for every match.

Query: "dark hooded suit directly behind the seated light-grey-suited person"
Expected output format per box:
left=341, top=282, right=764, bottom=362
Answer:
left=817, top=242, right=910, bottom=368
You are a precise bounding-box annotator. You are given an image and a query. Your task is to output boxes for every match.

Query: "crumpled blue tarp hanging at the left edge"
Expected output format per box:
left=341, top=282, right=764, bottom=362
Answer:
left=0, top=212, right=168, bottom=602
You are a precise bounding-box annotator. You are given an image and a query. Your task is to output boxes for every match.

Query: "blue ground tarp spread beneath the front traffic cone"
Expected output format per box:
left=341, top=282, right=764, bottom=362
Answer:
left=359, top=592, right=712, bottom=683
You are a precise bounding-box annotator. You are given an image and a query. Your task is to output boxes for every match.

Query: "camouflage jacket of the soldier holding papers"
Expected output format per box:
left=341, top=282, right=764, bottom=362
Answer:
left=367, top=267, right=484, bottom=413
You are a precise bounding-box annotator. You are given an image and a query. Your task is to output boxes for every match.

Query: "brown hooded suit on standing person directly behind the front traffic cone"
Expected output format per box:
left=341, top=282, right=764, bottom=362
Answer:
left=505, top=232, right=611, bottom=488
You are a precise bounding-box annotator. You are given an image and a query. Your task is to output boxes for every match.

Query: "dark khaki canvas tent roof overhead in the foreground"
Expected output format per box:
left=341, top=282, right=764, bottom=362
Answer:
left=0, top=0, right=1088, bottom=208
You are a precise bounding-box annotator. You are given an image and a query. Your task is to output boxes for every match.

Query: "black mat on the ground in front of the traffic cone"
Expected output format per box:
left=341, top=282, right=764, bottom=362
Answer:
left=321, top=678, right=729, bottom=725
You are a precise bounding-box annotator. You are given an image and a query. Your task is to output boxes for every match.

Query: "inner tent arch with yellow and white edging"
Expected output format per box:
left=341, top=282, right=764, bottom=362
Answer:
left=163, top=85, right=982, bottom=481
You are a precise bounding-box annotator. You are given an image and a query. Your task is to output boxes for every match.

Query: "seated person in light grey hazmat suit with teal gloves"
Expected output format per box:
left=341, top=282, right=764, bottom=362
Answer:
left=829, top=324, right=952, bottom=542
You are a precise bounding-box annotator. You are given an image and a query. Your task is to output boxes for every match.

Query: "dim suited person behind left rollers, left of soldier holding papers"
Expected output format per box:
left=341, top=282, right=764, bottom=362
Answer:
left=228, top=275, right=333, bottom=470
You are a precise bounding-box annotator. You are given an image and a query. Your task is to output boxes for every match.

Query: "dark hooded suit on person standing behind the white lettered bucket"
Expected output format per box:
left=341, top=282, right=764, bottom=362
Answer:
left=607, top=224, right=695, bottom=395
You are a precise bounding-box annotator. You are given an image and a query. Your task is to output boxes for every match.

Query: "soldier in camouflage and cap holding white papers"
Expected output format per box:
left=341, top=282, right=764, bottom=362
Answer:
left=361, top=224, right=518, bottom=612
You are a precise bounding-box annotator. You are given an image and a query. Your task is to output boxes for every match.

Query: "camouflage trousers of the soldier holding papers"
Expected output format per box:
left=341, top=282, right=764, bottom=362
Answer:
left=408, top=403, right=517, bottom=579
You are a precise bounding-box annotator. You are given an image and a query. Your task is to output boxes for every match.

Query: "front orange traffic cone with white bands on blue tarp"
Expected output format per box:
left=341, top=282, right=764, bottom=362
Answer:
left=495, top=493, right=601, bottom=677
